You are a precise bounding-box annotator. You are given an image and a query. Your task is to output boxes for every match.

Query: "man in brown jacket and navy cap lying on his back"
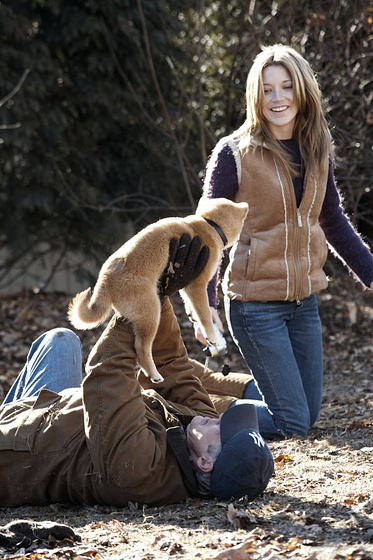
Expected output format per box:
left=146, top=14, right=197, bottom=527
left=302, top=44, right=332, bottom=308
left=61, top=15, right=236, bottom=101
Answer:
left=0, top=234, right=274, bottom=506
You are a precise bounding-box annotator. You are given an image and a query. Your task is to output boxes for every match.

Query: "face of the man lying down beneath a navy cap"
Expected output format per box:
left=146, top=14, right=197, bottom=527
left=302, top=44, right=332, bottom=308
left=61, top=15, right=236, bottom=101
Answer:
left=187, top=416, right=221, bottom=470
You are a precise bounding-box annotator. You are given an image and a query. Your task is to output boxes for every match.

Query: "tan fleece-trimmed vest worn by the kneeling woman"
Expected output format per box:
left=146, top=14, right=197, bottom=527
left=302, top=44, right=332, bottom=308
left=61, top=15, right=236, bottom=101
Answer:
left=223, top=148, right=327, bottom=301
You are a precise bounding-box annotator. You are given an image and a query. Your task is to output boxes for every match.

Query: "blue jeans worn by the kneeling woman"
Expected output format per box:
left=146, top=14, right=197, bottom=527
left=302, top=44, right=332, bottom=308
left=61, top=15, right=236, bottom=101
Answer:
left=225, top=294, right=323, bottom=439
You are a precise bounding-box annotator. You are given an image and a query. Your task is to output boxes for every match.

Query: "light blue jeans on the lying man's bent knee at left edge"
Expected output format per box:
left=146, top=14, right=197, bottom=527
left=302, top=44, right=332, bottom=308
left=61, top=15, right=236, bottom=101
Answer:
left=3, top=328, right=82, bottom=404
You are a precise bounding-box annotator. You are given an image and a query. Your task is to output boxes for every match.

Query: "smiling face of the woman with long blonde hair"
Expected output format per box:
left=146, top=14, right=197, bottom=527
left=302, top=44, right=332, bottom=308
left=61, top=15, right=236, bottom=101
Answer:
left=262, top=64, right=298, bottom=140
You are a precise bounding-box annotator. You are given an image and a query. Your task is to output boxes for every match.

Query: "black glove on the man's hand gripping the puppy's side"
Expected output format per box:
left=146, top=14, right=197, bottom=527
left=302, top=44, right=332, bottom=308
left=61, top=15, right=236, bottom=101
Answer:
left=159, top=233, right=210, bottom=300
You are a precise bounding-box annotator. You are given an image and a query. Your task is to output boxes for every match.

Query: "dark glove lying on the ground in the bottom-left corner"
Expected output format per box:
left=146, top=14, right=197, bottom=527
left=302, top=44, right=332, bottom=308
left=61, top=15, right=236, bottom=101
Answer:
left=0, top=519, right=81, bottom=550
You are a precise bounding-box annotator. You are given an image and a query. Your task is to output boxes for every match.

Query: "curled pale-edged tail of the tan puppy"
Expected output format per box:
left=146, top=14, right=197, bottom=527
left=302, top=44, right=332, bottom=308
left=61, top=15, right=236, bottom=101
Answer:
left=67, top=288, right=111, bottom=330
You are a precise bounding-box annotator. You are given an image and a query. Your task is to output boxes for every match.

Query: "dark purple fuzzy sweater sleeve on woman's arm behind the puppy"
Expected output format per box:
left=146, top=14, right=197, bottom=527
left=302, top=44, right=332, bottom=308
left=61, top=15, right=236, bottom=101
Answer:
left=203, top=138, right=239, bottom=308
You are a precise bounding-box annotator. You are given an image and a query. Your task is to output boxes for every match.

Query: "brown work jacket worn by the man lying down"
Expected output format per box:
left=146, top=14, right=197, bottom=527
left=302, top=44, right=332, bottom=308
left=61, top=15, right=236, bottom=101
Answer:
left=0, top=300, right=249, bottom=506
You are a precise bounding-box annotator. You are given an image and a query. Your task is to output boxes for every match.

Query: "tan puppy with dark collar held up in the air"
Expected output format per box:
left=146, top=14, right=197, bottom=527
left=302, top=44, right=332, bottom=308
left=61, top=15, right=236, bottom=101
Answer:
left=68, top=198, right=248, bottom=383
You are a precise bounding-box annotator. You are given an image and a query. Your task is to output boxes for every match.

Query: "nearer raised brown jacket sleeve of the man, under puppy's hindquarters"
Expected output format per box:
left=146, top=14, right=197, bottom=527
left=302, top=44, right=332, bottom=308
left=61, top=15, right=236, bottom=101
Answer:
left=83, top=316, right=167, bottom=488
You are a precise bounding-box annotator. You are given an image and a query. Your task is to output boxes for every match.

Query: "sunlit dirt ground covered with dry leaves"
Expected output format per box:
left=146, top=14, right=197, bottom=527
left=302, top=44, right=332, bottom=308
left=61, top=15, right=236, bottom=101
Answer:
left=0, top=273, right=373, bottom=560
